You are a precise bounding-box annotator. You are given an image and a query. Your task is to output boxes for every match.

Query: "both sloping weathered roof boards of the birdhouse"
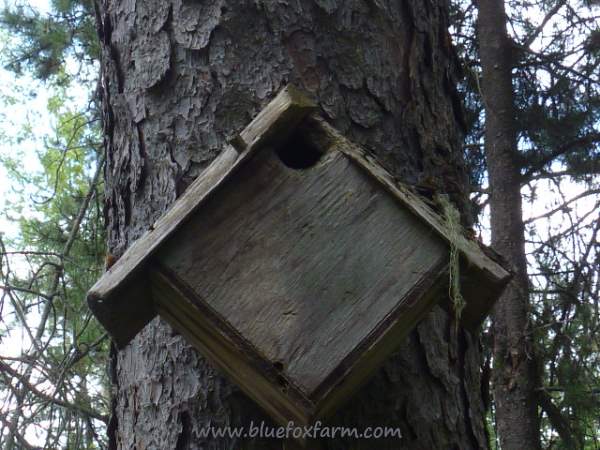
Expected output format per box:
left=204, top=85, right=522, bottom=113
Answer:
left=88, top=86, right=509, bottom=346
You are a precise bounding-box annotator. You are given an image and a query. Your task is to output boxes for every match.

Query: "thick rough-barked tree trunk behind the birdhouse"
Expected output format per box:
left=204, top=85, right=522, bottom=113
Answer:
left=97, top=0, right=487, bottom=450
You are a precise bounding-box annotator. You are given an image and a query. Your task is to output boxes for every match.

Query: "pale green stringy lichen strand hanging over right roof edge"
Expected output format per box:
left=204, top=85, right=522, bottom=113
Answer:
left=436, top=194, right=467, bottom=328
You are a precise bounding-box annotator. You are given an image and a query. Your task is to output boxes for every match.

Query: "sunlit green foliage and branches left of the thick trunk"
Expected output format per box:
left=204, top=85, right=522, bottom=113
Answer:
left=0, top=0, right=109, bottom=449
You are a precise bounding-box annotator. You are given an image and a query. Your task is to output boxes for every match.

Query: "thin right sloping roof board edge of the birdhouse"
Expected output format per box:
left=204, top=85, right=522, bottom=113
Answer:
left=305, top=115, right=511, bottom=283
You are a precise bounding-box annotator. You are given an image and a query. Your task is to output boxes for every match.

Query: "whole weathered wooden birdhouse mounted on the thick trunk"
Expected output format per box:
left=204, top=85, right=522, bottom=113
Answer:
left=88, top=87, right=509, bottom=424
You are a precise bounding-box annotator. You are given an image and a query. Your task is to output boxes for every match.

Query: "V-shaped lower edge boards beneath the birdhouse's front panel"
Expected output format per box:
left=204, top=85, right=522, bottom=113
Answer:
left=150, top=256, right=446, bottom=428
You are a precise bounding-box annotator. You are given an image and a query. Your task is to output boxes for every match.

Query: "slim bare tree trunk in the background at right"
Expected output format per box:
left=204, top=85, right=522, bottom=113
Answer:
left=478, top=0, right=540, bottom=450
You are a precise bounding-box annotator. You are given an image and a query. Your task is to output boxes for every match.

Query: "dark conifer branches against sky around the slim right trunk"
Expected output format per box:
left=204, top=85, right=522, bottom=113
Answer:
left=451, top=0, right=600, bottom=449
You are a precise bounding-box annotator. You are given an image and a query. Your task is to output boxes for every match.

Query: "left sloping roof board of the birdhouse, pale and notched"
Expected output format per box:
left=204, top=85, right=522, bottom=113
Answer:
left=88, top=86, right=314, bottom=344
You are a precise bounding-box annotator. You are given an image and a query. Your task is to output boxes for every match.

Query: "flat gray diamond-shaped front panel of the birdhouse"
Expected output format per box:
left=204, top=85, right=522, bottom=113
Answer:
left=156, top=145, right=447, bottom=396
